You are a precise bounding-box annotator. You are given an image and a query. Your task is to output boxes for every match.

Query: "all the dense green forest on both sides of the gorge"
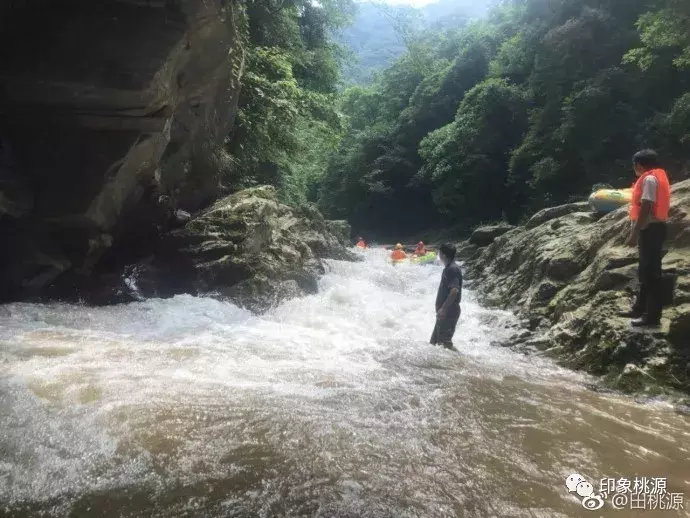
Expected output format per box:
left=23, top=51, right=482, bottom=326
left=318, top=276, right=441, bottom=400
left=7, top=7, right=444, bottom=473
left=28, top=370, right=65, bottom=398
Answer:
left=232, top=0, right=690, bottom=236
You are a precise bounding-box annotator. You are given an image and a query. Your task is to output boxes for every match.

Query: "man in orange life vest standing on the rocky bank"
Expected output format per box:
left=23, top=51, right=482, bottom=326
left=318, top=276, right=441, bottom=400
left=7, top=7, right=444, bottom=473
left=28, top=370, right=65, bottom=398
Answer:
left=621, top=149, right=671, bottom=327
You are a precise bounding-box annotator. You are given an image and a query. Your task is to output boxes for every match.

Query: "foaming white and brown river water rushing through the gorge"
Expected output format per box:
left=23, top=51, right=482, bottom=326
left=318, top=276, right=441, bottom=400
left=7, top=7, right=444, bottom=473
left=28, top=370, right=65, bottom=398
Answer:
left=0, top=250, right=690, bottom=517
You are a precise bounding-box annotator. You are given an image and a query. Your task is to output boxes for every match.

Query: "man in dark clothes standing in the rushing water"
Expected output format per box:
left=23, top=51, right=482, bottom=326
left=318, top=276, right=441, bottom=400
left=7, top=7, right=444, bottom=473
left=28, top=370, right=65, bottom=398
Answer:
left=431, top=244, right=462, bottom=349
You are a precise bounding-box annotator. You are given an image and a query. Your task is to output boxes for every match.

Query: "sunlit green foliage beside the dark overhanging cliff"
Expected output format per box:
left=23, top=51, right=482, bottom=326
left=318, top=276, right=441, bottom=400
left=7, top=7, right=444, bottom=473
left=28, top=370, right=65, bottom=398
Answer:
left=224, top=0, right=353, bottom=203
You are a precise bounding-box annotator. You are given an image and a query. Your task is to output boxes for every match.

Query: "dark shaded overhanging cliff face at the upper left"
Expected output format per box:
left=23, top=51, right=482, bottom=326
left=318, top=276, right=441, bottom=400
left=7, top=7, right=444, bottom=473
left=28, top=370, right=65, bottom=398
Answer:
left=0, top=0, right=244, bottom=300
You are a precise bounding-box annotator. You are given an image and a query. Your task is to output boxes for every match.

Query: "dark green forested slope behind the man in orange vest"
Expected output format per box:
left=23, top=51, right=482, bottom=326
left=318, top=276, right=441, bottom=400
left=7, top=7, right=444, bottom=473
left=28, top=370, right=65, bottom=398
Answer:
left=319, top=0, right=690, bottom=237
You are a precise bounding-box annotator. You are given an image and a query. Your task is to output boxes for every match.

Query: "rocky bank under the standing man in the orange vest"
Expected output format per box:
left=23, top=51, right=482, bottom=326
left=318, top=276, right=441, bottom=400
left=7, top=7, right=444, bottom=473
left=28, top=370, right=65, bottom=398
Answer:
left=467, top=181, right=690, bottom=392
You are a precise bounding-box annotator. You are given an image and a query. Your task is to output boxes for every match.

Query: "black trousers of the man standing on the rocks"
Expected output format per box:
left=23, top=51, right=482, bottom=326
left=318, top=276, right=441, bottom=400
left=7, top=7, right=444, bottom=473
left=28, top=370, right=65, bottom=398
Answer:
left=633, top=222, right=666, bottom=323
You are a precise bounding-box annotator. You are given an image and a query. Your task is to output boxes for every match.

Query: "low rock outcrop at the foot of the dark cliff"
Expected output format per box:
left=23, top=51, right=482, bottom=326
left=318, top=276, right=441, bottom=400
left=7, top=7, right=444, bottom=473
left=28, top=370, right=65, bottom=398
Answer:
left=107, top=187, right=354, bottom=311
